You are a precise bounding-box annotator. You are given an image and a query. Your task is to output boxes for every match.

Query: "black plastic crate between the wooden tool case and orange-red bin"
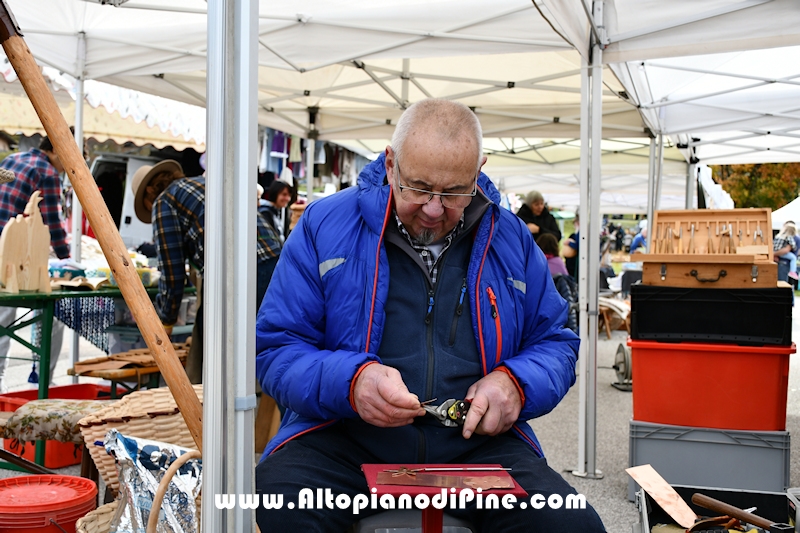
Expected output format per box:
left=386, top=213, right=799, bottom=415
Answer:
left=631, top=285, right=793, bottom=346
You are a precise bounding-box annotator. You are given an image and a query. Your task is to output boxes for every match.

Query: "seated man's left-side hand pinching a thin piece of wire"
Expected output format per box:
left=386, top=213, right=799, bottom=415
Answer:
left=353, top=364, right=425, bottom=428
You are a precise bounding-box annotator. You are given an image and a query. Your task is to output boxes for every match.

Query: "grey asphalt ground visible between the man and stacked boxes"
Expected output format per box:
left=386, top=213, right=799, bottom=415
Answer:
left=0, top=308, right=800, bottom=533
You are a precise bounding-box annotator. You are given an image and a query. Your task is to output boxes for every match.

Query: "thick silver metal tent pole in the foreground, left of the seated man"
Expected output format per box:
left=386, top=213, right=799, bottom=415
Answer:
left=202, top=0, right=258, bottom=533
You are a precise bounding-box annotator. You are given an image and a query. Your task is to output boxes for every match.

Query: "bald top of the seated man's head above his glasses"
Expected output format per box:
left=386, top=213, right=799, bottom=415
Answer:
left=392, top=98, right=483, bottom=169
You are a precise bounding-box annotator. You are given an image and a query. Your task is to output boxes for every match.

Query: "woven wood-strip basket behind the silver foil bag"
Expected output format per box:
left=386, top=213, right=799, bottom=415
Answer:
left=78, top=385, right=203, bottom=490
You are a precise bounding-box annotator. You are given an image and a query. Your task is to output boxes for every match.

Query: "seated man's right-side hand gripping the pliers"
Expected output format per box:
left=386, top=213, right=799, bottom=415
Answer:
left=461, top=371, right=522, bottom=439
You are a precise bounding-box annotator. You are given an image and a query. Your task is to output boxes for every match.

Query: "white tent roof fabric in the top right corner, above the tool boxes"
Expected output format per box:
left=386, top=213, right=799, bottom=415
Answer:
left=542, top=0, right=800, bottom=164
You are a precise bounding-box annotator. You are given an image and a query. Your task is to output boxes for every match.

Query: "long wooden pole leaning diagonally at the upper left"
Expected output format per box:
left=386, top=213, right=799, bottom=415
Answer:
left=0, top=0, right=203, bottom=450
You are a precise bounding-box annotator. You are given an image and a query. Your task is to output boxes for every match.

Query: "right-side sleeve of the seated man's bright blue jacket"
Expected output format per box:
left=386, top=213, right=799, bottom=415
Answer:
left=502, top=223, right=580, bottom=420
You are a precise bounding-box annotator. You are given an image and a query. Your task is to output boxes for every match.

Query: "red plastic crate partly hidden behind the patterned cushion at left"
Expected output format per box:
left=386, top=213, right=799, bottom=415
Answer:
left=0, top=383, right=111, bottom=468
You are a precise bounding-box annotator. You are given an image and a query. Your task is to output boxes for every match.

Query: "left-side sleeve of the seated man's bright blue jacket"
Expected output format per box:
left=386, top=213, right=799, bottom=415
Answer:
left=256, top=210, right=378, bottom=420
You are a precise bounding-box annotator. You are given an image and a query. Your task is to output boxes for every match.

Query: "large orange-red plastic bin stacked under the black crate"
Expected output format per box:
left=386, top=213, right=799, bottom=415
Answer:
left=628, top=340, right=796, bottom=431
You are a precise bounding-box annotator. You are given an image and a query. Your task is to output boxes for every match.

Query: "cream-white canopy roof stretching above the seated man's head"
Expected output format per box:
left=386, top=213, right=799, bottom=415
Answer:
left=4, top=0, right=687, bottom=212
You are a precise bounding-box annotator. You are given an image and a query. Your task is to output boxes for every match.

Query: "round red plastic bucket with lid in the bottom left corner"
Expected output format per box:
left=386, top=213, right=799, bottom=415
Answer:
left=0, top=475, right=97, bottom=533
